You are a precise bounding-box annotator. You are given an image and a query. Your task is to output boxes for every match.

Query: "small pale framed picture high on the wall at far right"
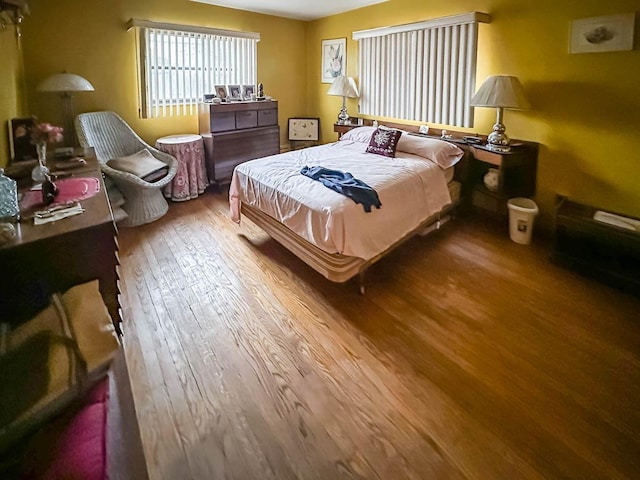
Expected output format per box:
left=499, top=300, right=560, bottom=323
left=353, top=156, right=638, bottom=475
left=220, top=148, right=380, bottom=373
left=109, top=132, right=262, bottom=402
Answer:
left=569, top=13, right=635, bottom=53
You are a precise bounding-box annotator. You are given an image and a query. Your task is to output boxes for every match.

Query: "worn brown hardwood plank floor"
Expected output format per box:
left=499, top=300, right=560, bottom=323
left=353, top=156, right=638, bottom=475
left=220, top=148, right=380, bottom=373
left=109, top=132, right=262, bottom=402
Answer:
left=120, top=192, right=640, bottom=480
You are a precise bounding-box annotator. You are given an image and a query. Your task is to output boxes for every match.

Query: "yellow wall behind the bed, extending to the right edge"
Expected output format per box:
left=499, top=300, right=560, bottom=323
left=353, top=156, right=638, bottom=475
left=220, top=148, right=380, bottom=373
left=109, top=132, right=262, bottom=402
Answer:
left=307, top=0, right=640, bottom=227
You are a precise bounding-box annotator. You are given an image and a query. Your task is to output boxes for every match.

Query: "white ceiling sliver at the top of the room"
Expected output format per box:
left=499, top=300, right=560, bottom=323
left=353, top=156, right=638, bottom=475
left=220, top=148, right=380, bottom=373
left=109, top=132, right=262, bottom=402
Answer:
left=191, top=0, right=389, bottom=20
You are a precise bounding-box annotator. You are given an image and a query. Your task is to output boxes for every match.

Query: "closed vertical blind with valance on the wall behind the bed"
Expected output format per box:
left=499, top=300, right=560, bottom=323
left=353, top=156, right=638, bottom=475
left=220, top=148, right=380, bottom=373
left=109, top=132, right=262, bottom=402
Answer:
left=353, top=12, right=490, bottom=127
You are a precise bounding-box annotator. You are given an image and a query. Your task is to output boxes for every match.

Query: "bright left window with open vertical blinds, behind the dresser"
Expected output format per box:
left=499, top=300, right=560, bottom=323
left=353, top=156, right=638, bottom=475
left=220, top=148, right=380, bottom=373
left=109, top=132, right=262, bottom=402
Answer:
left=129, top=20, right=260, bottom=118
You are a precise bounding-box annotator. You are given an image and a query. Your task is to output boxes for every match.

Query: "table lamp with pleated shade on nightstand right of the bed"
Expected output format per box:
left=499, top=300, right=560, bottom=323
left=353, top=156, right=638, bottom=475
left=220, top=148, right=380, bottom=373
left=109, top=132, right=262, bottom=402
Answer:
left=470, top=75, right=530, bottom=153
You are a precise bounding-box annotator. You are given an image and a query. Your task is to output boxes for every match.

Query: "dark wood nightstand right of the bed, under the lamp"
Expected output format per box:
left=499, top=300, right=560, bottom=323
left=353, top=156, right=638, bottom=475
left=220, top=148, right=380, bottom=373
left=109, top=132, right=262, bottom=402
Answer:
left=470, top=142, right=538, bottom=220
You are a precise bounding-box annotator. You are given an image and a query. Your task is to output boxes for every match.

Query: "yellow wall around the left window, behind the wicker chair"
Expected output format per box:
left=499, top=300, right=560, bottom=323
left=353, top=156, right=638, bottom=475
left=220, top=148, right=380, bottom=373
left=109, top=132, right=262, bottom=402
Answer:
left=18, top=0, right=306, bottom=149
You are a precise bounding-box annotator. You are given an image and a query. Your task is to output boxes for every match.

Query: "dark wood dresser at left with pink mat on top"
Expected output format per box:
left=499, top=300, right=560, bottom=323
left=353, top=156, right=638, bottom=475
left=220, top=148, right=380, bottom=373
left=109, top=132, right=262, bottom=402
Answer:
left=0, top=149, right=121, bottom=333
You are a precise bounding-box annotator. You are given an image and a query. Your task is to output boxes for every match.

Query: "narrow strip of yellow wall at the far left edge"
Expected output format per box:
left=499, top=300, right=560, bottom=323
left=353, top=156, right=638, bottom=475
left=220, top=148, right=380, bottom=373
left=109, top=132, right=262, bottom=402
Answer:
left=0, top=26, right=25, bottom=167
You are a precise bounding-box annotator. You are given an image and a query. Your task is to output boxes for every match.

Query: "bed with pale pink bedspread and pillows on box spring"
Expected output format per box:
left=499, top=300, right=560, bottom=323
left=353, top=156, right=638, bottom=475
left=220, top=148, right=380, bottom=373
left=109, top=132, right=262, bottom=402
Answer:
left=229, top=123, right=465, bottom=293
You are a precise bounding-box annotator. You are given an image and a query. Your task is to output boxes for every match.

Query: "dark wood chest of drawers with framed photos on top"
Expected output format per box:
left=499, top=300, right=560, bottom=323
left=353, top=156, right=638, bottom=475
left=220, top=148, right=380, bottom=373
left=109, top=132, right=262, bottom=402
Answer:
left=198, top=100, right=280, bottom=183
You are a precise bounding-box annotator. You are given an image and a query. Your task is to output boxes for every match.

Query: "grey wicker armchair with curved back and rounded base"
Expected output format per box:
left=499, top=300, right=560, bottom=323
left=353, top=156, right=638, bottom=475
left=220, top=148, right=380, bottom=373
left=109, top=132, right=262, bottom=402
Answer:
left=75, top=112, right=178, bottom=227
